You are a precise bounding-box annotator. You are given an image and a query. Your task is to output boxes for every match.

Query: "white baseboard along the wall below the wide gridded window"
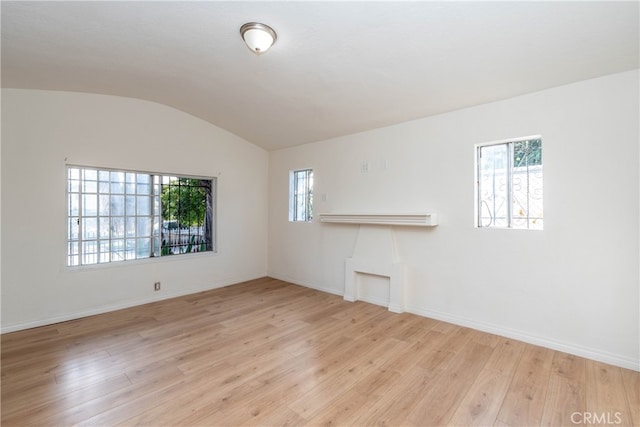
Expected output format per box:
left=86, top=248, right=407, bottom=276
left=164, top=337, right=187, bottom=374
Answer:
left=0, top=275, right=265, bottom=334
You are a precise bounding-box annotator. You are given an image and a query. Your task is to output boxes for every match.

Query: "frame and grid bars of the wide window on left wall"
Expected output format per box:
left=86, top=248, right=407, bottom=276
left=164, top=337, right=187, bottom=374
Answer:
left=65, top=164, right=217, bottom=269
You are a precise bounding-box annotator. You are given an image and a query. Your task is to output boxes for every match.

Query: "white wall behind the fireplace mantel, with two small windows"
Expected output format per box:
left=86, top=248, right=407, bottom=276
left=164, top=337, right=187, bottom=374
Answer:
left=268, top=70, right=640, bottom=370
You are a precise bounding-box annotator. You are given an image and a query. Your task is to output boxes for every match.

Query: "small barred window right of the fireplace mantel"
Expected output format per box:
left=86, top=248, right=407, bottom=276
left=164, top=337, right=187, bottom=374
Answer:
left=476, top=137, right=543, bottom=230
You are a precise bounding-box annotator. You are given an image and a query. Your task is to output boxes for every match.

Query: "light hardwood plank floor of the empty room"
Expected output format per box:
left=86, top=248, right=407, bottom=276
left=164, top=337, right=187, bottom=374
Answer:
left=1, top=278, right=640, bottom=426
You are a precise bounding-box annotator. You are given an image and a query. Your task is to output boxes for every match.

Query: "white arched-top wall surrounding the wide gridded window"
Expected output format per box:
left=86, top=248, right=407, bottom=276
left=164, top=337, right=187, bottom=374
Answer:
left=1, top=89, right=268, bottom=332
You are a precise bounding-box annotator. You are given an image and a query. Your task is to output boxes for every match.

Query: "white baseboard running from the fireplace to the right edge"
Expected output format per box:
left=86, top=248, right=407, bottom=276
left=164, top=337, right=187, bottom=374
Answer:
left=406, top=306, right=640, bottom=372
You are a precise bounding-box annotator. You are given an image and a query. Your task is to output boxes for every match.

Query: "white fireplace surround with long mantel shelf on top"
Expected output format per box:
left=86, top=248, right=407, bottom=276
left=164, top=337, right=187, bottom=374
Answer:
left=320, top=213, right=438, bottom=313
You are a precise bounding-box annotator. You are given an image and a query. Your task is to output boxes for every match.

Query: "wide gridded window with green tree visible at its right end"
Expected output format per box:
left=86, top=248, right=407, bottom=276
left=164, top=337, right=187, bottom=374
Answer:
left=67, top=166, right=215, bottom=266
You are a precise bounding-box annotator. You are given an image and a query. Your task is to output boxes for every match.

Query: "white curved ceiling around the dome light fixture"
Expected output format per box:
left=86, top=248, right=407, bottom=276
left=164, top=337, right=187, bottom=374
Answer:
left=0, top=1, right=640, bottom=150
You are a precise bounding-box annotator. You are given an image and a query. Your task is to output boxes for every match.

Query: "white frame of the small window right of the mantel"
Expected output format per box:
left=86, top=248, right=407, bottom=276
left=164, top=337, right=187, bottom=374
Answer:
left=474, top=135, right=544, bottom=231
